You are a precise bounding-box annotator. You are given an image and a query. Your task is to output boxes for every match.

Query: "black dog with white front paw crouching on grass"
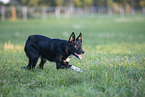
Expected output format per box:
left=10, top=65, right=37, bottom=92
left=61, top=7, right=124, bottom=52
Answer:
left=24, top=32, right=84, bottom=72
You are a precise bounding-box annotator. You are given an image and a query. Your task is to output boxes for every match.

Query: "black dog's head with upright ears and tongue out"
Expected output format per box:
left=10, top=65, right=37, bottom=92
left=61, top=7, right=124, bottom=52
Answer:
left=68, top=32, right=85, bottom=59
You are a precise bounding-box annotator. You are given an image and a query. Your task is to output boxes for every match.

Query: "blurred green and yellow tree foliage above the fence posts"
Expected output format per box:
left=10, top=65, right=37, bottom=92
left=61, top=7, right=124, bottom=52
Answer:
left=10, top=0, right=145, bottom=8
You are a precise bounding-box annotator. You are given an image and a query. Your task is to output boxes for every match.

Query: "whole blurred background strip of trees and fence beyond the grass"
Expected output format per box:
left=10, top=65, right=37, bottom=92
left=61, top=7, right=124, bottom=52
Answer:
left=0, top=0, right=145, bottom=21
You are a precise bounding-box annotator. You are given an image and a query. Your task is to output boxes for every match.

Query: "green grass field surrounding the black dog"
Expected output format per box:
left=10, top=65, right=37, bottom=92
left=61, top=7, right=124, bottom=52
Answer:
left=0, top=16, right=145, bottom=97
